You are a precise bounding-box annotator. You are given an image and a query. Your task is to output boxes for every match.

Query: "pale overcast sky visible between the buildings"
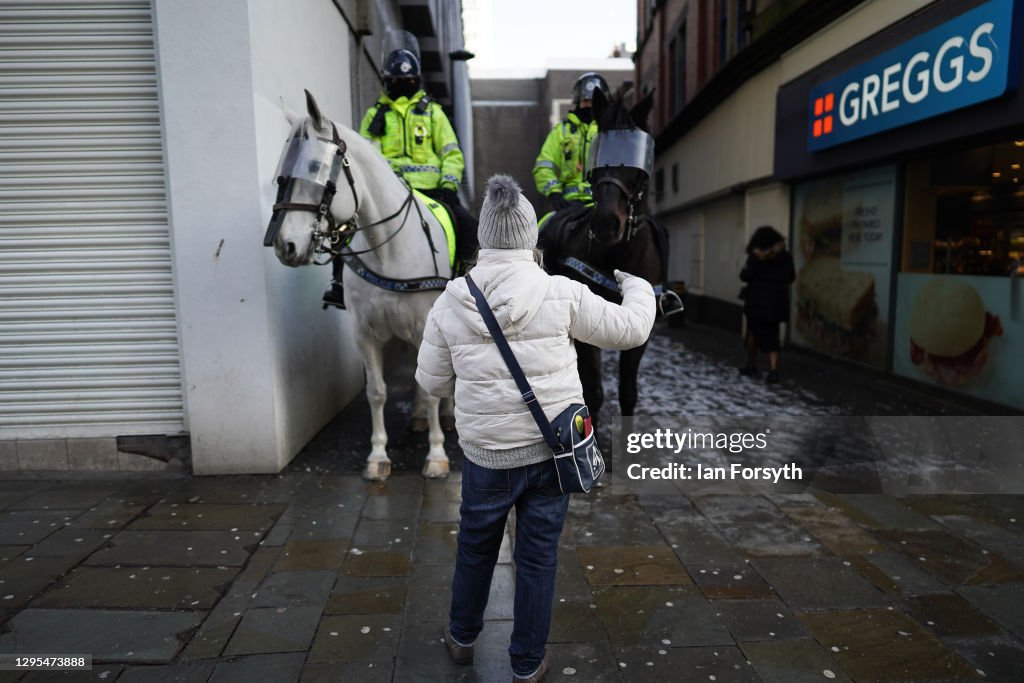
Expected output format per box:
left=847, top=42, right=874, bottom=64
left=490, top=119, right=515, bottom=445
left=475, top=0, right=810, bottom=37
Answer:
left=463, top=0, right=637, bottom=73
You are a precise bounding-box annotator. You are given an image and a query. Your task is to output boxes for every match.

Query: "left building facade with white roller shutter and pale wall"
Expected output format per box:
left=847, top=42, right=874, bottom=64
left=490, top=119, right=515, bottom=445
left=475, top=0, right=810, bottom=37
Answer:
left=0, top=0, right=471, bottom=474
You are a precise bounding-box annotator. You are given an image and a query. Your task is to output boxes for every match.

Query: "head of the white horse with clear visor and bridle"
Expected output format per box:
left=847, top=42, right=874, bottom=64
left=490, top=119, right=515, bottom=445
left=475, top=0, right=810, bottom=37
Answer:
left=263, top=90, right=358, bottom=267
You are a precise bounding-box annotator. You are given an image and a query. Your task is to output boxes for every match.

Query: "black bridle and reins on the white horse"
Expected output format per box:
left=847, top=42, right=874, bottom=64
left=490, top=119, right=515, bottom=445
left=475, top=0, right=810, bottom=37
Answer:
left=263, top=122, right=433, bottom=265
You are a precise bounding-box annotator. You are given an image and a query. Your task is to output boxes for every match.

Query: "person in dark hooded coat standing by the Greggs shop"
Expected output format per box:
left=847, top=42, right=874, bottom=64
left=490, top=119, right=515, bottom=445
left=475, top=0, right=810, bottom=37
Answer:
left=739, top=225, right=797, bottom=383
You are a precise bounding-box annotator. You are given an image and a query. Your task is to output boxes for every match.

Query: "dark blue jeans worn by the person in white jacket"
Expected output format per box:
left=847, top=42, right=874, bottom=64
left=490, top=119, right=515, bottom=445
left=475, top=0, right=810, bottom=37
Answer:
left=449, top=458, right=569, bottom=678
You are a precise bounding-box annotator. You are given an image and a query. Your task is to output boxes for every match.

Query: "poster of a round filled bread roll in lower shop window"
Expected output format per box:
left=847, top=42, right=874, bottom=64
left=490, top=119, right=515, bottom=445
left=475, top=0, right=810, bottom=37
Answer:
left=893, top=272, right=1024, bottom=409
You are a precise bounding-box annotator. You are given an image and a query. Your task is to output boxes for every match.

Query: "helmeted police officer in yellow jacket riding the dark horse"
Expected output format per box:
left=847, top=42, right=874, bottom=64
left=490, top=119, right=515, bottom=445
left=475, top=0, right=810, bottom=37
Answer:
left=534, top=72, right=610, bottom=211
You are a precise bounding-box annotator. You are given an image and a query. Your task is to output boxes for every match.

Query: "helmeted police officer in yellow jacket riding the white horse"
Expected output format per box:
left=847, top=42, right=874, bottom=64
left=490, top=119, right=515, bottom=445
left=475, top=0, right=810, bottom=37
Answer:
left=324, top=31, right=477, bottom=308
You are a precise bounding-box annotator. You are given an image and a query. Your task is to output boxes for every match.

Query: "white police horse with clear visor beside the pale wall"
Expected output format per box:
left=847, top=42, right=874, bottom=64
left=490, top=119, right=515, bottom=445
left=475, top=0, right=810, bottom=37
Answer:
left=264, top=90, right=453, bottom=480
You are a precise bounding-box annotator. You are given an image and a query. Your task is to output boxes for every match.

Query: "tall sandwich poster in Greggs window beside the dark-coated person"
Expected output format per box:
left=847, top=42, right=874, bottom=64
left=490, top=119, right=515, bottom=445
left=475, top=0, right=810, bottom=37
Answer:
left=792, top=166, right=896, bottom=368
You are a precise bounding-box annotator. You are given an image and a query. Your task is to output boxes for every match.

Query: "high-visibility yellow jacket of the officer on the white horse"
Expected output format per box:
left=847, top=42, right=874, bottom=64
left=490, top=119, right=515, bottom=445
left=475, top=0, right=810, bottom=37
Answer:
left=359, top=90, right=465, bottom=191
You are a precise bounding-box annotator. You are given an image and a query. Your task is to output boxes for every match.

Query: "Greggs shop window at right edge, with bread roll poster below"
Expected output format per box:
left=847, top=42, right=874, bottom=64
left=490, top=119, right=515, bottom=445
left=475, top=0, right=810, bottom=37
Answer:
left=893, top=135, right=1024, bottom=408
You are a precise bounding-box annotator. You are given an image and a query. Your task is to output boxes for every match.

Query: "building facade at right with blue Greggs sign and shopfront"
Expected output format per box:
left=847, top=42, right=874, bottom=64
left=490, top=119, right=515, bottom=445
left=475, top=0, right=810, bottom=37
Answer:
left=636, top=0, right=1024, bottom=409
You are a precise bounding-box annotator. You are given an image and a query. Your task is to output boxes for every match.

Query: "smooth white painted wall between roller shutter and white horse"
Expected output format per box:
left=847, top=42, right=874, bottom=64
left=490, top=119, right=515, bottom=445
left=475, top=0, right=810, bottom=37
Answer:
left=154, top=0, right=362, bottom=474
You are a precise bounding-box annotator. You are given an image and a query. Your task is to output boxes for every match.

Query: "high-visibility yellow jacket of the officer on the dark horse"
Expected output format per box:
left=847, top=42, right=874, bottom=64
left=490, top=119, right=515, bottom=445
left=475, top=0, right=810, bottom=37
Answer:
left=534, top=112, right=597, bottom=202
